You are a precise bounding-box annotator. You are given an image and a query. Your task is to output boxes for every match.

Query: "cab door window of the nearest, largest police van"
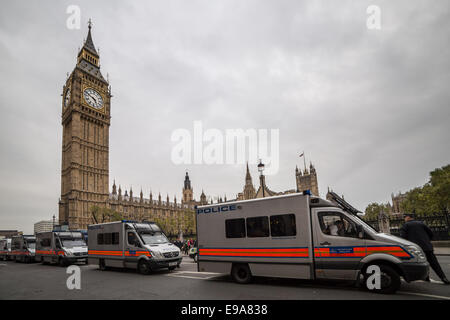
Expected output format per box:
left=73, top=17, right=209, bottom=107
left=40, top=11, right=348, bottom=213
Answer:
left=319, top=212, right=358, bottom=238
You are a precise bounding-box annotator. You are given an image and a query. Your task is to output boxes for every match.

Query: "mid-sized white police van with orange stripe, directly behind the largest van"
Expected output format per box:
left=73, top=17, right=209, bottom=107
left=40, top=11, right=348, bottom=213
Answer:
left=88, top=220, right=182, bottom=274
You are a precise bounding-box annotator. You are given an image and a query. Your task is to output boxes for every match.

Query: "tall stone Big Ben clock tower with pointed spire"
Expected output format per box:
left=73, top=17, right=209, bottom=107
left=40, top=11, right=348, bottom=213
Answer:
left=59, top=21, right=111, bottom=230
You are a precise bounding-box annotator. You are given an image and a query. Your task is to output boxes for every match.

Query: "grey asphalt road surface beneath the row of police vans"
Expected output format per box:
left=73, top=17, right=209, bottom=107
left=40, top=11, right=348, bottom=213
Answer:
left=0, top=256, right=450, bottom=300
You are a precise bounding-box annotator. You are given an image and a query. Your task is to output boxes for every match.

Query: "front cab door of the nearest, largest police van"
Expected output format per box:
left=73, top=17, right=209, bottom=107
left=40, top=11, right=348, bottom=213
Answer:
left=311, top=208, right=366, bottom=280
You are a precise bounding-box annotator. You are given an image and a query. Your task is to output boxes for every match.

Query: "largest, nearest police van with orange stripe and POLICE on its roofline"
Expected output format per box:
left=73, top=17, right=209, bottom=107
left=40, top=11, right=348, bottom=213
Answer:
left=196, top=192, right=429, bottom=293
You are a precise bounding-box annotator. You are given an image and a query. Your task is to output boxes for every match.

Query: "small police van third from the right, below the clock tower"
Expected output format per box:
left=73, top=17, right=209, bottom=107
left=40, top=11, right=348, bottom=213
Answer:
left=36, top=231, right=88, bottom=267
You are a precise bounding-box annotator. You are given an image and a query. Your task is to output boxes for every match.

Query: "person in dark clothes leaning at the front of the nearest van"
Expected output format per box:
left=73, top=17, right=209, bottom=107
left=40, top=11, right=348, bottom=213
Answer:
left=400, top=213, right=450, bottom=284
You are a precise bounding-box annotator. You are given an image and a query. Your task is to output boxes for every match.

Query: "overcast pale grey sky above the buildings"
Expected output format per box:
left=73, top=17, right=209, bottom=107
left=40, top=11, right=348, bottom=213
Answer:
left=0, top=0, right=450, bottom=233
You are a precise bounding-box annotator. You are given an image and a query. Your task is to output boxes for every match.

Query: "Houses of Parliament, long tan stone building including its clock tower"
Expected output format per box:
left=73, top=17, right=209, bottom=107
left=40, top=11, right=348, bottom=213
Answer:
left=59, top=22, right=318, bottom=234
